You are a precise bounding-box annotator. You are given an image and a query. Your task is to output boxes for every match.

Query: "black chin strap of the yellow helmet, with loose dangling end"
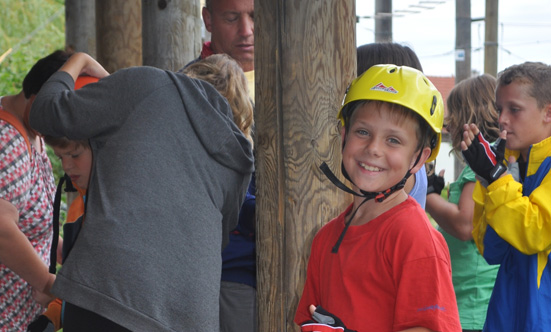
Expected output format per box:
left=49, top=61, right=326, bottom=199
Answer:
left=320, top=153, right=421, bottom=253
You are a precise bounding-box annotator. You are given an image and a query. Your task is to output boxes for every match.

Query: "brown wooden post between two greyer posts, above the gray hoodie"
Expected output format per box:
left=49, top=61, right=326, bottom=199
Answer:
left=96, top=0, right=142, bottom=73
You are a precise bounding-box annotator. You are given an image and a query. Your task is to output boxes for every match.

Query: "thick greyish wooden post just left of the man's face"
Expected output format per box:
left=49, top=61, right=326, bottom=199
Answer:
left=142, top=0, right=203, bottom=71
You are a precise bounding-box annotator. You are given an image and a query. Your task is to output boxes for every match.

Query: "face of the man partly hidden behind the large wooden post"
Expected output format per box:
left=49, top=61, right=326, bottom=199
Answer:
left=203, top=0, right=254, bottom=72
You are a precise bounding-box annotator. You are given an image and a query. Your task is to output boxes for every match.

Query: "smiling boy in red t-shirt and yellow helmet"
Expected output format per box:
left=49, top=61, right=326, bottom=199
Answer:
left=295, top=65, right=461, bottom=332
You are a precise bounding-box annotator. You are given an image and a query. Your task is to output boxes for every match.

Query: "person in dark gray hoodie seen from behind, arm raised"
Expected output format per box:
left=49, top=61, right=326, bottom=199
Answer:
left=30, top=53, right=254, bottom=332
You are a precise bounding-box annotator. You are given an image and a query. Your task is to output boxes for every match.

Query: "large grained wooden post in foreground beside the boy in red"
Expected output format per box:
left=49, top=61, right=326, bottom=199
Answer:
left=255, top=0, right=356, bottom=332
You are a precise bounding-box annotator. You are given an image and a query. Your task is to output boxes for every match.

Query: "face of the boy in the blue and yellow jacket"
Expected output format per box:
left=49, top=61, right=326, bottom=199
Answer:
left=496, top=81, right=551, bottom=160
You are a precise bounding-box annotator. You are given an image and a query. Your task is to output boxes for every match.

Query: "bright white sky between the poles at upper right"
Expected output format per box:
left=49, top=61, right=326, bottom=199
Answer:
left=356, top=0, right=551, bottom=76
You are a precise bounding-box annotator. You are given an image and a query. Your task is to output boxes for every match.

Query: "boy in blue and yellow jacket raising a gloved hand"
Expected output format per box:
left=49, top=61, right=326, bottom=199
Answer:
left=462, top=62, right=551, bottom=332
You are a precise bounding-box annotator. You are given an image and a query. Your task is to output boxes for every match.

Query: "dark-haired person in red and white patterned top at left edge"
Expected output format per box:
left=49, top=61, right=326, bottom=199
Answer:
left=0, top=51, right=69, bottom=331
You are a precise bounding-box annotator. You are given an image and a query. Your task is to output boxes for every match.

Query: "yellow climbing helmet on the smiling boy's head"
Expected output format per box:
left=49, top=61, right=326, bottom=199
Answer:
left=337, top=65, right=444, bottom=162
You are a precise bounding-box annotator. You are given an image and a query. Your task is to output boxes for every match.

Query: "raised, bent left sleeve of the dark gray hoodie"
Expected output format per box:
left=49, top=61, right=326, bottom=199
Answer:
left=30, top=67, right=175, bottom=140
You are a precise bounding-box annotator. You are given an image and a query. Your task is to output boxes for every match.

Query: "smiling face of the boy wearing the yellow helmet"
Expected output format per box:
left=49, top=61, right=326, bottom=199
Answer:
left=341, top=102, right=431, bottom=192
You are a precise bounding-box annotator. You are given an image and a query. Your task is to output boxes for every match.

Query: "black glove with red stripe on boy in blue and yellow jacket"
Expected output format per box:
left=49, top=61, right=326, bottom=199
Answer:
left=461, top=133, right=507, bottom=184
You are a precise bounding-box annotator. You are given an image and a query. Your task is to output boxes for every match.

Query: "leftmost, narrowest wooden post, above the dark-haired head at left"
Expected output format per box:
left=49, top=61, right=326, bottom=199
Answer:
left=65, top=0, right=96, bottom=58
